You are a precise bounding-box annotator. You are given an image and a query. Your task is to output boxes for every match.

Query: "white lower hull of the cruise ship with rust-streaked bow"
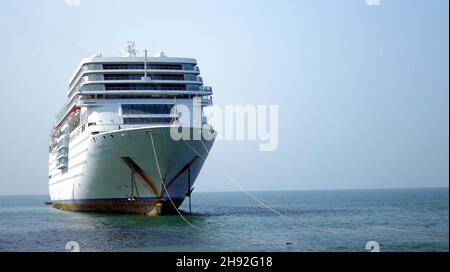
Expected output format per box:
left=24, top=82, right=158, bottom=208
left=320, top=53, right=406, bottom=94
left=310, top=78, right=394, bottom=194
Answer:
left=49, top=126, right=214, bottom=215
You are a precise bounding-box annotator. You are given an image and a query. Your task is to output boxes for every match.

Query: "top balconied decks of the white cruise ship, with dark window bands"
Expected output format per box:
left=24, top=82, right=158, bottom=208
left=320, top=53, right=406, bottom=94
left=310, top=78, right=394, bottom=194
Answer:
left=67, top=53, right=212, bottom=105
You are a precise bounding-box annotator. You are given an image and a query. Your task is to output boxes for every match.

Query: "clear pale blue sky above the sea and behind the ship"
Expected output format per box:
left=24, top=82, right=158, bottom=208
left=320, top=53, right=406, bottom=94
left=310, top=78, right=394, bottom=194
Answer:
left=0, top=0, right=449, bottom=194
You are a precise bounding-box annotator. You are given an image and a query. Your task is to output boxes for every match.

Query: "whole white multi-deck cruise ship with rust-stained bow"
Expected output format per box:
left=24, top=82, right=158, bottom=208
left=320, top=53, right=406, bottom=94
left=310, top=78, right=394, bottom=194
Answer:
left=49, top=43, right=216, bottom=215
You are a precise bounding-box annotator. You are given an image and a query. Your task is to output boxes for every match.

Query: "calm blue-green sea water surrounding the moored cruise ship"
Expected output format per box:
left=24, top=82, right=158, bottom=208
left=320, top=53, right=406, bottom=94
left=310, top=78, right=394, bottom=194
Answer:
left=0, top=188, right=449, bottom=251
